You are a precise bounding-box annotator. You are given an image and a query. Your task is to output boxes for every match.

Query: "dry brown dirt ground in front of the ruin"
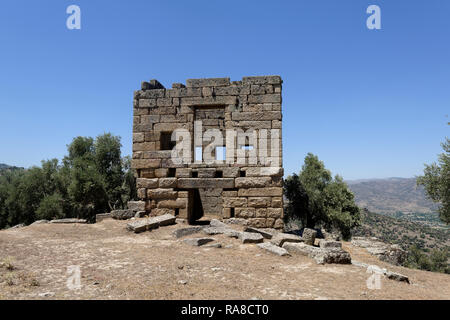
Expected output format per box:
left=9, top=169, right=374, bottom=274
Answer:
left=0, top=220, right=450, bottom=299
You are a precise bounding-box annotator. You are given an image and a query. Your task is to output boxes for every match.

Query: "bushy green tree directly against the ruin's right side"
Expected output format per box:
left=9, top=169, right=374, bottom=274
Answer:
left=284, top=153, right=360, bottom=239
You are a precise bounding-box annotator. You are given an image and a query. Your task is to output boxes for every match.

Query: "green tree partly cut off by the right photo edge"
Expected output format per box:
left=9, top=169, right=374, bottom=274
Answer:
left=417, top=138, right=450, bottom=224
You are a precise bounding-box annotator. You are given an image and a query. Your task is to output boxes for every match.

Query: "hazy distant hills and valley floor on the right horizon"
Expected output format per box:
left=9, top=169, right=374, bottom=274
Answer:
left=346, top=178, right=438, bottom=215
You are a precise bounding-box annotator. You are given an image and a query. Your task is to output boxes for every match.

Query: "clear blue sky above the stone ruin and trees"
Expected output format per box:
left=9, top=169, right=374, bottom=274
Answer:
left=0, top=0, right=450, bottom=180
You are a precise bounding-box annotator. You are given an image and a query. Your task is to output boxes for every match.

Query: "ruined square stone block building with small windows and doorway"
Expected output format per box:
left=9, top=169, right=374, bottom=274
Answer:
left=132, top=76, right=283, bottom=229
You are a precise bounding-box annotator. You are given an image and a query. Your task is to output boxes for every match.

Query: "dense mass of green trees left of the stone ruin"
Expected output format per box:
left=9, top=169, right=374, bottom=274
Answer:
left=0, top=133, right=136, bottom=228
